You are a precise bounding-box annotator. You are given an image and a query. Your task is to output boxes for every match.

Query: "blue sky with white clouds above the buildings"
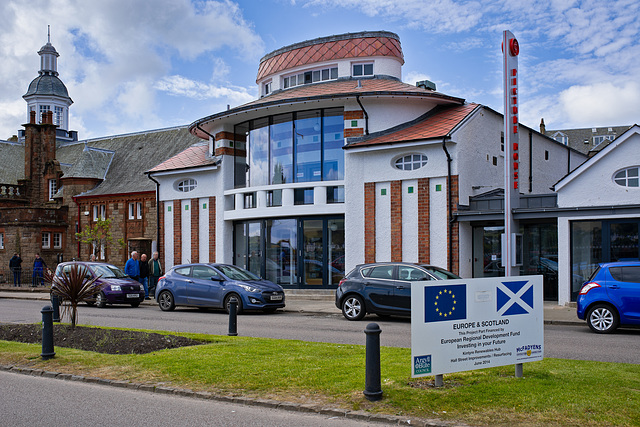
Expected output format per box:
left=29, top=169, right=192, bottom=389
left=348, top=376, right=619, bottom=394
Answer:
left=0, top=0, right=640, bottom=140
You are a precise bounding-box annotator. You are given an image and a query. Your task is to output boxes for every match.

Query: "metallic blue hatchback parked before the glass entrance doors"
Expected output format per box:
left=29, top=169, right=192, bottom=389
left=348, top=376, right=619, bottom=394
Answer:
left=155, top=264, right=284, bottom=313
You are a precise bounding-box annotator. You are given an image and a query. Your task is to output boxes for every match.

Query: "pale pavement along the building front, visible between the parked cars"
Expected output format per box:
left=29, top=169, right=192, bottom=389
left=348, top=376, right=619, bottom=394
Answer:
left=0, top=285, right=585, bottom=325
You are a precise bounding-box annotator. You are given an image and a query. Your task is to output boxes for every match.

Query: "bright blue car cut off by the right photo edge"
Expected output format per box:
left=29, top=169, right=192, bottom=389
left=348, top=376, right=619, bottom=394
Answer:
left=577, top=261, right=640, bottom=334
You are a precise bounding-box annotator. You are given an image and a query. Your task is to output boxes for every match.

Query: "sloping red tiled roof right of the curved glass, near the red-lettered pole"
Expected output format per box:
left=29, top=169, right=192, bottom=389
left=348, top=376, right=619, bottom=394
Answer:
left=346, top=104, right=479, bottom=148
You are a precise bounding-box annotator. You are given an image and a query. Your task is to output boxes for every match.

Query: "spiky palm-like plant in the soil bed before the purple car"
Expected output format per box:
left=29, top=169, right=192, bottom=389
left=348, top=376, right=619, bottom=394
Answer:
left=45, top=264, right=100, bottom=329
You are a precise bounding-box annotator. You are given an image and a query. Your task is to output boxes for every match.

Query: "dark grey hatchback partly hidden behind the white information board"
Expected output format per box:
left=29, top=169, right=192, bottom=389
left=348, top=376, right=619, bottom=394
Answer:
left=336, top=263, right=460, bottom=320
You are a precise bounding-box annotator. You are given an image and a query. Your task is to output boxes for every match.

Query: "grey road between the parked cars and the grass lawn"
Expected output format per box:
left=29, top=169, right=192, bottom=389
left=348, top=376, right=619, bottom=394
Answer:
left=0, top=300, right=640, bottom=363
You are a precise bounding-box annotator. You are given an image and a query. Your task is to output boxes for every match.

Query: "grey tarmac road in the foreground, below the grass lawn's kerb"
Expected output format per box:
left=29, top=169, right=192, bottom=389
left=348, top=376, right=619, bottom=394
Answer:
left=0, top=372, right=380, bottom=427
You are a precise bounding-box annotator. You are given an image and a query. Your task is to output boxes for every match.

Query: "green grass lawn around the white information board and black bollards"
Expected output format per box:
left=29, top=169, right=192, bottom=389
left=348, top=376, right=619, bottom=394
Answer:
left=0, top=332, right=640, bottom=426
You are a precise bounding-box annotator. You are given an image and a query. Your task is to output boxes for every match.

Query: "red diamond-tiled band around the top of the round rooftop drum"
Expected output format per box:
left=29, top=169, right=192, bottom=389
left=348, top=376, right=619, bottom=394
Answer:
left=256, top=33, right=404, bottom=80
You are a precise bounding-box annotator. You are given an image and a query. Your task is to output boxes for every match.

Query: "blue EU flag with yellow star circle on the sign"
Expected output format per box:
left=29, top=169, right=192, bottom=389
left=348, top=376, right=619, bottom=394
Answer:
left=424, top=285, right=467, bottom=323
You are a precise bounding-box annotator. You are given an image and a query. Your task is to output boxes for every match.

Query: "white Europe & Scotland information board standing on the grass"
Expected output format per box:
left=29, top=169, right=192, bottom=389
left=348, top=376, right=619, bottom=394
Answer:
left=411, top=276, right=544, bottom=377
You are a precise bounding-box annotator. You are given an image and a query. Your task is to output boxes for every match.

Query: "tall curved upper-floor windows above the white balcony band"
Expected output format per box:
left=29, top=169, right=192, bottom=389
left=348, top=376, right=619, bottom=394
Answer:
left=234, top=108, right=344, bottom=188
